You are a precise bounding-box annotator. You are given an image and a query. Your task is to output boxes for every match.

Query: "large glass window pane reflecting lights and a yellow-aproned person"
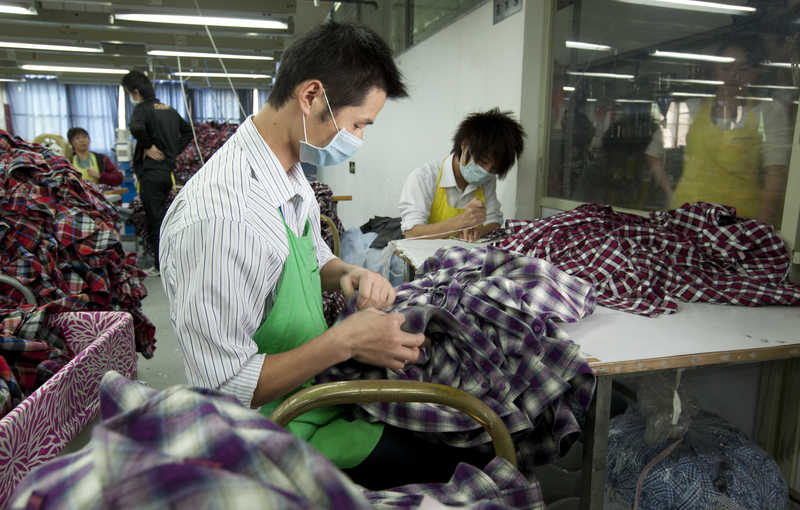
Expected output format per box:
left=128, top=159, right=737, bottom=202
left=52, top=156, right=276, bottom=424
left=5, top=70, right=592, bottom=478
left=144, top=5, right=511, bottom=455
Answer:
left=543, top=0, right=798, bottom=225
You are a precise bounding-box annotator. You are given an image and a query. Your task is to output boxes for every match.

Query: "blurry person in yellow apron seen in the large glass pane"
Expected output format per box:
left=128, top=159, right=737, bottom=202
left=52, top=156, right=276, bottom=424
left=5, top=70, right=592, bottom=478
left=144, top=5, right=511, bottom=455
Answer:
left=645, top=36, right=792, bottom=225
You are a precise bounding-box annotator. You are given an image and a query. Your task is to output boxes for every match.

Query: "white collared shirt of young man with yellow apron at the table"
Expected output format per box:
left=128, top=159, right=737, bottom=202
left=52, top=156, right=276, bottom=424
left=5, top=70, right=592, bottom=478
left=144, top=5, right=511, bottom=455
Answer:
left=399, top=154, right=503, bottom=231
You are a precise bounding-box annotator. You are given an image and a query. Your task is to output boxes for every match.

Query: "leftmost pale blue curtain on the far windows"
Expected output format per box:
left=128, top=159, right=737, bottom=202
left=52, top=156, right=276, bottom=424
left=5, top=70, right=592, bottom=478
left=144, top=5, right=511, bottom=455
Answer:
left=7, top=79, right=70, bottom=141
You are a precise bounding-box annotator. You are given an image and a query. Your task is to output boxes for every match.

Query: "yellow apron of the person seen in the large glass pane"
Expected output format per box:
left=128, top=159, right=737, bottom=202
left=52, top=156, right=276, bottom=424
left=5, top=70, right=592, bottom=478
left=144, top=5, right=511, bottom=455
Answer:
left=671, top=102, right=762, bottom=218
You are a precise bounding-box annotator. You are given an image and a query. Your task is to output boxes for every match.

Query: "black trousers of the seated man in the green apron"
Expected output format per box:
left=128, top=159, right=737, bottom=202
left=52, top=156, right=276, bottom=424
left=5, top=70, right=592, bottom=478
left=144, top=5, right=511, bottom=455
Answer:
left=343, top=425, right=494, bottom=490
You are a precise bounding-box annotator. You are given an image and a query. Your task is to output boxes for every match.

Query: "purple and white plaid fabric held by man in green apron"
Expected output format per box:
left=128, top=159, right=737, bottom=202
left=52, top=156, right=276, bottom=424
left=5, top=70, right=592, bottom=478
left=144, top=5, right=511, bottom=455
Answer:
left=316, top=247, right=595, bottom=472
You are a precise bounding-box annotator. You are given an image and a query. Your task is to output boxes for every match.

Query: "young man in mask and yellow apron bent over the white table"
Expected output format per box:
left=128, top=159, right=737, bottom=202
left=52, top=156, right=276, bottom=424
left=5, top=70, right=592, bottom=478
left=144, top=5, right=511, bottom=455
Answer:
left=400, top=108, right=525, bottom=241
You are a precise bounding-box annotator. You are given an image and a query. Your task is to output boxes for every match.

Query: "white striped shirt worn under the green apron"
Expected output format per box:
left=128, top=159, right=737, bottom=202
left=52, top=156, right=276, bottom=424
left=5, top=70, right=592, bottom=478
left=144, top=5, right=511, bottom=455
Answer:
left=159, top=118, right=334, bottom=407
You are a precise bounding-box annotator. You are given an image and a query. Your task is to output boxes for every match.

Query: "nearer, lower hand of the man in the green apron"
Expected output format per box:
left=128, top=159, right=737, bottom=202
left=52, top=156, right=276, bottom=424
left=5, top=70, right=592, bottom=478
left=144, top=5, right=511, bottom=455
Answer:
left=328, top=308, right=425, bottom=370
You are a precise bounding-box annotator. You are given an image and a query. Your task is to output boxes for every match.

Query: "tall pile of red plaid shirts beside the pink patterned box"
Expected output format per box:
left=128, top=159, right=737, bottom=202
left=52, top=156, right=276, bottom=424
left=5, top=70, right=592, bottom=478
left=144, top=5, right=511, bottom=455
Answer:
left=0, top=131, right=155, bottom=415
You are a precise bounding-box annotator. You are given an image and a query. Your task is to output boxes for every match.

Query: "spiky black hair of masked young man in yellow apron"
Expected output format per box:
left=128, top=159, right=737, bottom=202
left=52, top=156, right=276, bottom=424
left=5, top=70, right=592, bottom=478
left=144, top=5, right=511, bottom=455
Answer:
left=453, top=108, right=526, bottom=179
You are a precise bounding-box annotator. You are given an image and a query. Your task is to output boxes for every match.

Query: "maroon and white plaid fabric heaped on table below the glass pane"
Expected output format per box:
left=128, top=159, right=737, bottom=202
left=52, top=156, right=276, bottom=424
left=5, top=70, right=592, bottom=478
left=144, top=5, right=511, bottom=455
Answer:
left=492, top=202, right=800, bottom=317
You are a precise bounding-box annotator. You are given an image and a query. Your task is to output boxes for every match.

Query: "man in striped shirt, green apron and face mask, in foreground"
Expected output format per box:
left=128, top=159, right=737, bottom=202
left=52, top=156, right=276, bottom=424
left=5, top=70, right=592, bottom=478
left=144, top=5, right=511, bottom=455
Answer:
left=159, top=22, right=488, bottom=488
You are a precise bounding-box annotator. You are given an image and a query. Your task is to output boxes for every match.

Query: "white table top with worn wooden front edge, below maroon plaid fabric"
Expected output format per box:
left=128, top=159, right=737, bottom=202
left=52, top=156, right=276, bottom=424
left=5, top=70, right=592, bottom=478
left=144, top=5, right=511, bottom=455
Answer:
left=562, top=303, right=800, bottom=373
